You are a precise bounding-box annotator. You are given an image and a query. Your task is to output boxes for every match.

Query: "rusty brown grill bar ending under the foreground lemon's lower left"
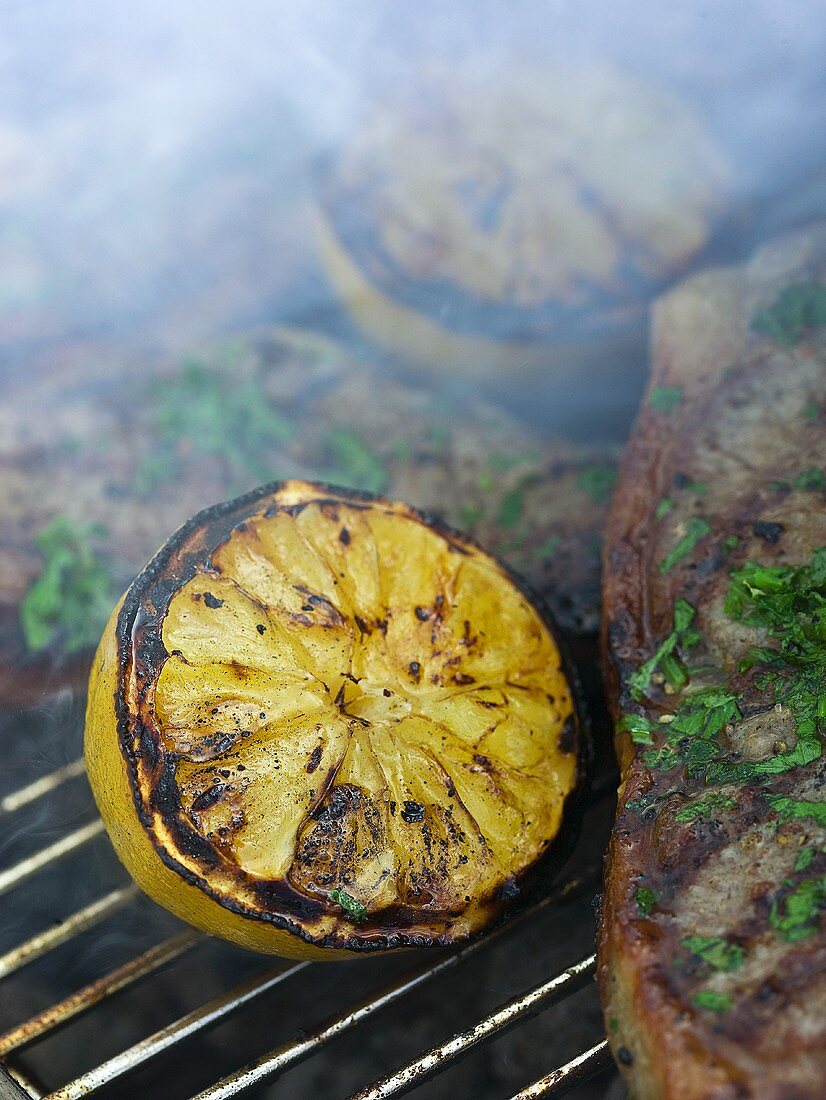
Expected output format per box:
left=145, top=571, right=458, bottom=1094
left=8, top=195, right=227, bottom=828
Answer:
left=0, top=928, right=205, bottom=1058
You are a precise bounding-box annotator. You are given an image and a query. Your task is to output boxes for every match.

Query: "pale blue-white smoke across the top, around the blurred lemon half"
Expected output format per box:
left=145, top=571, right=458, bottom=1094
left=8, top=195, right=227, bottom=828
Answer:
left=0, top=0, right=826, bottom=415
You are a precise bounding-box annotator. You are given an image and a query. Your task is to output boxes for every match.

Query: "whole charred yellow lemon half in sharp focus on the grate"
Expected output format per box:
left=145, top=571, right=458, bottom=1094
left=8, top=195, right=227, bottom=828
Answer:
left=86, top=482, right=581, bottom=958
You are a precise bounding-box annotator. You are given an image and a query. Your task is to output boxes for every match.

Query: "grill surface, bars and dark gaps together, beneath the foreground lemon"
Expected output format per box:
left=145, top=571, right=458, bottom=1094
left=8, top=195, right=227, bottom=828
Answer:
left=0, top=699, right=614, bottom=1100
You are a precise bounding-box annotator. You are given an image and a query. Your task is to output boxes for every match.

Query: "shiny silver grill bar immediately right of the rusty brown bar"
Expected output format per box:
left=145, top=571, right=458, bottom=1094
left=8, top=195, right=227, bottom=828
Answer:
left=42, top=963, right=309, bottom=1100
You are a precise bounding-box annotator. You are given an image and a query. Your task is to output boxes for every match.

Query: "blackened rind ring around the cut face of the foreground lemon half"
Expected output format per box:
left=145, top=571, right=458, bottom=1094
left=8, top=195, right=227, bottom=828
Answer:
left=114, top=481, right=592, bottom=953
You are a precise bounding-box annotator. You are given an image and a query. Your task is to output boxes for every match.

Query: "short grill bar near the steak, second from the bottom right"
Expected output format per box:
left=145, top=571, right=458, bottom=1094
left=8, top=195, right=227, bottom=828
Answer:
left=351, top=955, right=596, bottom=1100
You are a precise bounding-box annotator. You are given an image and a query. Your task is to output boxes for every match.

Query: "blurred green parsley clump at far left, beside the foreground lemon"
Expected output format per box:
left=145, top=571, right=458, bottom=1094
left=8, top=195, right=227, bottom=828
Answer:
left=20, top=516, right=118, bottom=653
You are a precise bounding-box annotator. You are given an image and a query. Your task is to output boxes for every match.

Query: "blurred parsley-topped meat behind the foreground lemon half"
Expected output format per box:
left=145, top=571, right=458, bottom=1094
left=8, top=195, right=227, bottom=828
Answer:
left=0, top=329, right=615, bottom=702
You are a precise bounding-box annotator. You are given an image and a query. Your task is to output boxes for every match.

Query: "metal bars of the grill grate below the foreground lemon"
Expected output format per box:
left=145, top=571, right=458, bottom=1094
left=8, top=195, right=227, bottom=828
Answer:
left=0, top=760, right=613, bottom=1100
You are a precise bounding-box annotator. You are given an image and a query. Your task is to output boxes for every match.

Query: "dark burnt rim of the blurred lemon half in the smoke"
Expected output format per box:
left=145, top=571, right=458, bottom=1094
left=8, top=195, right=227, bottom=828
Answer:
left=315, top=154, right=659, bottom=347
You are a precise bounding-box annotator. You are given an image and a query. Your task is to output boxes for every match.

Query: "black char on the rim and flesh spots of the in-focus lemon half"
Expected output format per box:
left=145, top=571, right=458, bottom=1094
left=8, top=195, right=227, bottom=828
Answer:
left=115, top=483, right=588, bottom=952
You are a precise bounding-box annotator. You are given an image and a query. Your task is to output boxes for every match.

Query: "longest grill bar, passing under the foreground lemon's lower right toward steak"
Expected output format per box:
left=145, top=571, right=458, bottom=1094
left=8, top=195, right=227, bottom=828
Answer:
left=190, top=868, right=597, bottom=1100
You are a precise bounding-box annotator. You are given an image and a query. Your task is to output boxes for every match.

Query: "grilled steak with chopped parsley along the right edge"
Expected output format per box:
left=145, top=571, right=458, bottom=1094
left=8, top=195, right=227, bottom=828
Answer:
left=599, top=224, right=826, bottom=1100
